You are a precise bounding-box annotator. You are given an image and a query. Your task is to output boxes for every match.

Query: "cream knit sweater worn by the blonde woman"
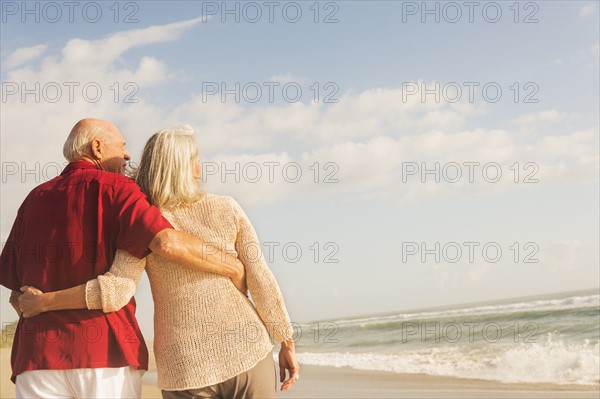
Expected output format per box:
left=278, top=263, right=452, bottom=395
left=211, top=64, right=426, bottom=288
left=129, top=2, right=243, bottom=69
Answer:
left=86, top=194, right=293, bottom=390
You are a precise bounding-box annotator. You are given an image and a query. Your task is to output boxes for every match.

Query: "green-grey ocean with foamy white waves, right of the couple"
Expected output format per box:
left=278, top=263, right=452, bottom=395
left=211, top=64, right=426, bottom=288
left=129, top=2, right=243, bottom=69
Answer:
left=295, top=290, right=600, bottom=386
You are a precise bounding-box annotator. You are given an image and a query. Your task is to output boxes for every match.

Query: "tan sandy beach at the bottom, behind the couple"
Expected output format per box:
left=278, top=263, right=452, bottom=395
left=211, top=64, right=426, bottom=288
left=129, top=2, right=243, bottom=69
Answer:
left=0, top=348, right=599, bottom=399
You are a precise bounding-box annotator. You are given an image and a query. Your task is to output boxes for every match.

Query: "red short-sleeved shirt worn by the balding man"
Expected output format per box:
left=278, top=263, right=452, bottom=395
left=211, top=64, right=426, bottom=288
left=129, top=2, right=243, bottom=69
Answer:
left=0, top=161, right=172, bottom=381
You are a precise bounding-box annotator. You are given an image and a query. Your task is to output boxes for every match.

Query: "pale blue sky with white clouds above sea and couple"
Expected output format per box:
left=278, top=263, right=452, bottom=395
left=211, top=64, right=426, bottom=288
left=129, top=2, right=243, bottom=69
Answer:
left=0, top=1, right=600, bottom=331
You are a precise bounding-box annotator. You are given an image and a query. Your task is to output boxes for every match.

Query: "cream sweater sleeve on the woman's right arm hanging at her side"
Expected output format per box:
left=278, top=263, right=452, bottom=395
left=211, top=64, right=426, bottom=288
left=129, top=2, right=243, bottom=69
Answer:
left=231, top=199, right=294, bottom=342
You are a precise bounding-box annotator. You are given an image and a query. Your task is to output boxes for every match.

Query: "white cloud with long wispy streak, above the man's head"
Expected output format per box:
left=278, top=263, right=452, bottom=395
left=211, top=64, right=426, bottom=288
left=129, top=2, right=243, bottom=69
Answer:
left=2, top=18, right=202, bottom=153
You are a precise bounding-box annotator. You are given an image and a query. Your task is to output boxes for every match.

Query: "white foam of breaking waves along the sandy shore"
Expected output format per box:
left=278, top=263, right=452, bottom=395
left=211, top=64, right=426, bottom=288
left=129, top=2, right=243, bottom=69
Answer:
left=298, top=335, right=600, bottom=385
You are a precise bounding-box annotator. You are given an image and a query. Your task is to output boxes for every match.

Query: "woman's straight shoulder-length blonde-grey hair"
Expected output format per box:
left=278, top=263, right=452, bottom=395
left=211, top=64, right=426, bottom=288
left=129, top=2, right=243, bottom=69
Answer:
left=134, top=125, right=204, bottom=209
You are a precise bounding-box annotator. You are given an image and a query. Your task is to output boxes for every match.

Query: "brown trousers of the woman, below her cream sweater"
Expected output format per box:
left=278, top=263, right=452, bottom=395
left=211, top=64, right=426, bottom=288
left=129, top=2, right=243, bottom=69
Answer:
left=162, top=352, right=277, bottom=399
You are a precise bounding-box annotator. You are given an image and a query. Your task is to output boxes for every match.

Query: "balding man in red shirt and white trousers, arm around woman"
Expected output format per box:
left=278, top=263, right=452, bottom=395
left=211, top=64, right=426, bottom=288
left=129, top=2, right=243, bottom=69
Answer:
left=0, top=119, right=244, bottom=398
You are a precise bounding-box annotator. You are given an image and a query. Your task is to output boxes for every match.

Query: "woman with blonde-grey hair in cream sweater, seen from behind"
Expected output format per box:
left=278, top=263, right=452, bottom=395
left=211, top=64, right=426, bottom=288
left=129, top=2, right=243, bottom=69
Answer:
left=22, top=126, right=299, bottom=398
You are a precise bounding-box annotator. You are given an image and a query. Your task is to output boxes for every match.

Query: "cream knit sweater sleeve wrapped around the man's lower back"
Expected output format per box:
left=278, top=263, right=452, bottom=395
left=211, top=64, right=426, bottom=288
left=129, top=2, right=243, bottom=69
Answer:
left=85, top=249, right=146, bottom=313
